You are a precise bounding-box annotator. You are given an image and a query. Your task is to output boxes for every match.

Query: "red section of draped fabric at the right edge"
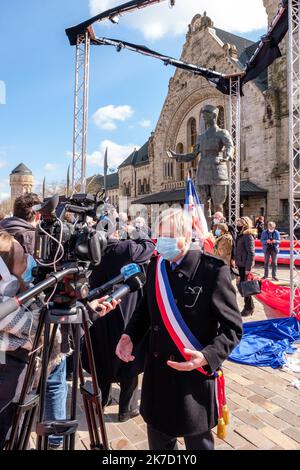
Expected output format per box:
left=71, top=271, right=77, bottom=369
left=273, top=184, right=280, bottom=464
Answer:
left=256, top=281, right=300, bottom=320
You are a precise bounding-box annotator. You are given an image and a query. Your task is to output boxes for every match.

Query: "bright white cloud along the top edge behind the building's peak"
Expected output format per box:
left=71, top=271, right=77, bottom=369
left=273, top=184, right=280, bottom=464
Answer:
left=90, top=0, right=267, bottom=40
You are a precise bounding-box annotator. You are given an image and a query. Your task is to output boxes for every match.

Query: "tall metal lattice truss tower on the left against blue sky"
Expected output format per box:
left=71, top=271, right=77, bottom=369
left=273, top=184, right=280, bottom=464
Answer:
left=71, top=31, right=90, bottom=193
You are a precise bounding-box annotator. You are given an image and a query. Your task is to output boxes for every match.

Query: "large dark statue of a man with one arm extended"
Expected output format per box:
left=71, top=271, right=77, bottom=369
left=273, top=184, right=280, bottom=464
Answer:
left=167, top=105, right=234, bottom=218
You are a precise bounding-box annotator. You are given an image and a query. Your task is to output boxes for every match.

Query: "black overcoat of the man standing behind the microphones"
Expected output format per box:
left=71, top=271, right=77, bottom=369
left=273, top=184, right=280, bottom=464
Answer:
left=82, top=238, right=155, bottom=386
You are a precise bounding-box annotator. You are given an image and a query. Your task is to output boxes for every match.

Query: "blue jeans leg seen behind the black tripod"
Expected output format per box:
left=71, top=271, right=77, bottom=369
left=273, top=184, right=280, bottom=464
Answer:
left=45, top=357, right=68, bottom=445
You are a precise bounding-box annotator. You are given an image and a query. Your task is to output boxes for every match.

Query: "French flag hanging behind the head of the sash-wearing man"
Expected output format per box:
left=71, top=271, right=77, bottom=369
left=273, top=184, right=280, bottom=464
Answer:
left=185, top=177, right=214, bottom=253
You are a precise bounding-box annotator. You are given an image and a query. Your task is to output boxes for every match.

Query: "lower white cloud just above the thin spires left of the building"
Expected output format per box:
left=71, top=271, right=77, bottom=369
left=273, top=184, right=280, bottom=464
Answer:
left=87, top=139, right=139, bottom=171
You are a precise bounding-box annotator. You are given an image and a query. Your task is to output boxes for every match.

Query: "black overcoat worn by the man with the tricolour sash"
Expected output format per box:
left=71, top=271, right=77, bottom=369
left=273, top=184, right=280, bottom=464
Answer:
left=126, top=250, right=242, bottom=437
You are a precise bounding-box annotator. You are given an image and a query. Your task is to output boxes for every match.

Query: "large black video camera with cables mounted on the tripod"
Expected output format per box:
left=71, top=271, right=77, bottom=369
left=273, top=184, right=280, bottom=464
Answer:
left=33, top=194, right=107, bottom=269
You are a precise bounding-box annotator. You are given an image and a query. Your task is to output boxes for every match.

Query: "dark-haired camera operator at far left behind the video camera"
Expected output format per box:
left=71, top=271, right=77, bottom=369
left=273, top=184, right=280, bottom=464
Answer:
left=0, top=193, right=41, bottom=256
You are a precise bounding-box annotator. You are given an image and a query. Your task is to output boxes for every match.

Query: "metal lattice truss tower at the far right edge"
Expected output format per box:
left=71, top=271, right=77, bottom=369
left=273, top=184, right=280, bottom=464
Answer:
left=288, top=0, right=300, bottom=316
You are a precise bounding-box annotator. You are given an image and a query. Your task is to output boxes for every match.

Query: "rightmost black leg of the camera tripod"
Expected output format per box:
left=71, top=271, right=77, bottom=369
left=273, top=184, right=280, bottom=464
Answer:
left=82, top=309, right=109, bottom=450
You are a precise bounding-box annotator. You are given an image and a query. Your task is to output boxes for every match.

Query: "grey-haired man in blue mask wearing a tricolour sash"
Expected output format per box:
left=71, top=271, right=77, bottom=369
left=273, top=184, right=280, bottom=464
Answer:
left=116, top=209, right=242, bottom=450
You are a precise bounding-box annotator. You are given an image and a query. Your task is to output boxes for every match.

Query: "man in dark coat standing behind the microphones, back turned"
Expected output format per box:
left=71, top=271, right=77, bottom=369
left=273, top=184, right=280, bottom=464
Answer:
left=83, top=226, right=155, bottom=421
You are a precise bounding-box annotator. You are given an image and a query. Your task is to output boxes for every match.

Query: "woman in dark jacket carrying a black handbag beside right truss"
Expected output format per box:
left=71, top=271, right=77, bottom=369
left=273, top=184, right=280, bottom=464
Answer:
left=235, top=217, right=257, bottom=317
